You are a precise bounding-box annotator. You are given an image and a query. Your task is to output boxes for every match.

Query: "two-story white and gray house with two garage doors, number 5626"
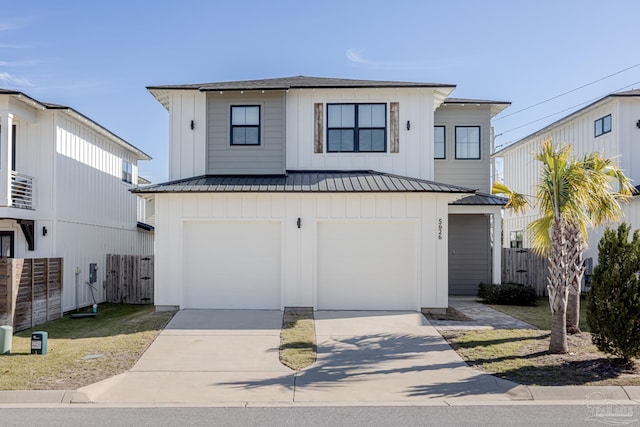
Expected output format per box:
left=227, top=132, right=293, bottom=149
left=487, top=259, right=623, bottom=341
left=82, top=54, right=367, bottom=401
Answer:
left=135, top=76, right=508, bottom=310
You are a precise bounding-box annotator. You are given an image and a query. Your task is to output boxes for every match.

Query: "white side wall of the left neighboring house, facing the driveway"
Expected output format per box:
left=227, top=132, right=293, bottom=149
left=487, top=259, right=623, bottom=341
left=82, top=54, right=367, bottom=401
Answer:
left=54, top=114, right=153, bottom=311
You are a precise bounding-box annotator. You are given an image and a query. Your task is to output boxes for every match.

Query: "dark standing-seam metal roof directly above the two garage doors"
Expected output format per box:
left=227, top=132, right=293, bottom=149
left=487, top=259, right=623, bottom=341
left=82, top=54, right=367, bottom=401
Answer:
left=132, top=171, right=475, bottom=194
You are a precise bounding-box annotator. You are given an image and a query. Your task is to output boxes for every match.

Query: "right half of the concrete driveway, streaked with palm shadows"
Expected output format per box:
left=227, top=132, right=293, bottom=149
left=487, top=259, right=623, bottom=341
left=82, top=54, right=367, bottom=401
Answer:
left=295, top=311, right=530, bottom=403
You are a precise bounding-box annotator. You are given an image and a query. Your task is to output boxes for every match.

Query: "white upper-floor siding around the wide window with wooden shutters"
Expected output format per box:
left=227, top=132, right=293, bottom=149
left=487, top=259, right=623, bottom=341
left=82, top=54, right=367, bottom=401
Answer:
left=286, top=88, right=436, bottom=180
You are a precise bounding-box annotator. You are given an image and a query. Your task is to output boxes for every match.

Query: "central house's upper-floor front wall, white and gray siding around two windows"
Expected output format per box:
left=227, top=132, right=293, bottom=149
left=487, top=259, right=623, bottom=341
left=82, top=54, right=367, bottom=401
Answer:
left=169, top=88, right=440, bottom=180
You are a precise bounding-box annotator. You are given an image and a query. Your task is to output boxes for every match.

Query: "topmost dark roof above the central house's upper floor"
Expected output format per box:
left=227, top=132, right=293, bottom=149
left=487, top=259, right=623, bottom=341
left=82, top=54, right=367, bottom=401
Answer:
left=147, top=76, right=456, bottom=91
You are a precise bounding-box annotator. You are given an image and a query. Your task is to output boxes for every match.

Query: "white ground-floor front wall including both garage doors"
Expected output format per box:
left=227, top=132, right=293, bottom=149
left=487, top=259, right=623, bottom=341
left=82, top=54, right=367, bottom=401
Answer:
left=154, top=193, right=449, bottom=310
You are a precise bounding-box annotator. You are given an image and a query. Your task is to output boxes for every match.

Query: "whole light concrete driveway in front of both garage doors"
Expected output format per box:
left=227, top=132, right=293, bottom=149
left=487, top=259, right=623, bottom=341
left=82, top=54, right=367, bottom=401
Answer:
left=79, top=310, right=531, bottom=404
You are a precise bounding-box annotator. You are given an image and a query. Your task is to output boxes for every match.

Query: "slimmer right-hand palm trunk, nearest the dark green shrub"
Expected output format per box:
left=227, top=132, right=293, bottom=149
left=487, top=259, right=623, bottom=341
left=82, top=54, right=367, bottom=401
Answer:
left=567, top=223, right=585, bottom=334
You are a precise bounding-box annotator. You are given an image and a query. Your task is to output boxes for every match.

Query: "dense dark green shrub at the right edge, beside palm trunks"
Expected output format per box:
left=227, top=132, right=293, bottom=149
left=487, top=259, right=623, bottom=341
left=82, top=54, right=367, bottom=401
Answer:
left=587, top=223, right=640, bottom=361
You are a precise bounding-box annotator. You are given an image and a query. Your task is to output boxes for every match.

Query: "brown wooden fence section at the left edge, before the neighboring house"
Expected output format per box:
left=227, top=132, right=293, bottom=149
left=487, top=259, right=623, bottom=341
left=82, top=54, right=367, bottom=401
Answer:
left=0, top=258, right=63, bottom=332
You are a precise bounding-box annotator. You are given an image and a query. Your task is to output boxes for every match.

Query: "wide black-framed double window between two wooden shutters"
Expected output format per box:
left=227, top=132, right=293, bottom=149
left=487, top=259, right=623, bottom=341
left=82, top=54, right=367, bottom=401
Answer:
left=327, top=104, right=387, bottom=153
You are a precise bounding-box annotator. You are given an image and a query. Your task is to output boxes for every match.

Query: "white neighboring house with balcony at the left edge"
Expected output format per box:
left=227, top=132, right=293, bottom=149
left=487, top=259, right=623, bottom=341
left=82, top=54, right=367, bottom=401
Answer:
left=0, top=89, right=153, bottom=311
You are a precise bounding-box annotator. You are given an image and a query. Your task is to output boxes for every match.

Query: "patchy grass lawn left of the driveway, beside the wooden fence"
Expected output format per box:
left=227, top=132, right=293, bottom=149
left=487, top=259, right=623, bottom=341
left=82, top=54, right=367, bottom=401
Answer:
left=0, top=304, right=175, bottom=390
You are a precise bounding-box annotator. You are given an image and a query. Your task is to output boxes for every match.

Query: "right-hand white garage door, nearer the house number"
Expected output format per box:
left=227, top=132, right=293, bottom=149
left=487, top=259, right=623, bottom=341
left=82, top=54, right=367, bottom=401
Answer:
left=318, top=221, right=419, bottom=310
